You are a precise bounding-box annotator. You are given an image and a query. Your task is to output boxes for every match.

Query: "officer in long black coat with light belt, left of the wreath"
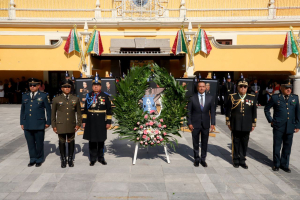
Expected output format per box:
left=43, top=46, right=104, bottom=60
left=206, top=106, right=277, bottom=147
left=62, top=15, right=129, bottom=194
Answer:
left=82, top=76, right=112, bottom=166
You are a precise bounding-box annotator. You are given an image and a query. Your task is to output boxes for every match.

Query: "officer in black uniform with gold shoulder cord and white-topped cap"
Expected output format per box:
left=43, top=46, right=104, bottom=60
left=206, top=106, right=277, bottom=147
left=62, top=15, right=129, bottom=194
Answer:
left=226, top=78, right=257, bottom=169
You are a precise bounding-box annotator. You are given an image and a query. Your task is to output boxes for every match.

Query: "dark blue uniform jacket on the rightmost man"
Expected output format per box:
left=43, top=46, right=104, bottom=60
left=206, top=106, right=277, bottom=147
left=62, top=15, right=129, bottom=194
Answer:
left=264, top=94, right=300, bottom=134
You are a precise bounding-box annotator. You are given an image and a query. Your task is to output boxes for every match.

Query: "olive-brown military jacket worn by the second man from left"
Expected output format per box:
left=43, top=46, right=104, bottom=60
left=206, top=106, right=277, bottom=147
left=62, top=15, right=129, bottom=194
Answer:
left=51, top=94, right=81, bottom=134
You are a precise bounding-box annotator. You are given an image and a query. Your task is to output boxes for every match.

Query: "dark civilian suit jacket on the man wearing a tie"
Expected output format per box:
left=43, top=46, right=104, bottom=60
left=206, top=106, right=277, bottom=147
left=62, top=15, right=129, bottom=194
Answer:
left=187, top=92, right=216, bottom=129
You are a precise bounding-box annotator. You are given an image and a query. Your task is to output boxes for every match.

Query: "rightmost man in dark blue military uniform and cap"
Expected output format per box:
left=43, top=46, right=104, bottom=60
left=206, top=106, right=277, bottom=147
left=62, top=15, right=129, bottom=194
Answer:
left=264, top=80, right=300, bottom=173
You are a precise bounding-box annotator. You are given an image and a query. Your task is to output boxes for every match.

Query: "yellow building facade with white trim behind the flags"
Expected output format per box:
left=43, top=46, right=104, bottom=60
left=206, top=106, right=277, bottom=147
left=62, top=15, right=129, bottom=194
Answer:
left=0, top=0, right=300, bottom=93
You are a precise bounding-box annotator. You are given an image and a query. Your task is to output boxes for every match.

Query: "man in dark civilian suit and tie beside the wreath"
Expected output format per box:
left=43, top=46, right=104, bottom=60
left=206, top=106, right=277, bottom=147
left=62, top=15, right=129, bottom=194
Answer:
left=188, top=81, right=216, bottom=167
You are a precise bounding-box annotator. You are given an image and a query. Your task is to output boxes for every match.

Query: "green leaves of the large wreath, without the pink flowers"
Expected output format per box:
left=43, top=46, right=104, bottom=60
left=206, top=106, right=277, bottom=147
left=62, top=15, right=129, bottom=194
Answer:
left=113, top=64, right=187, bottom=148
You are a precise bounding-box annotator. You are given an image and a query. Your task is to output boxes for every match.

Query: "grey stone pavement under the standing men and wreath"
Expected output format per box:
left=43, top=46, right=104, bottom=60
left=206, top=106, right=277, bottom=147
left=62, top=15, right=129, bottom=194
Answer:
left=0, top=105, right=300, bottom=200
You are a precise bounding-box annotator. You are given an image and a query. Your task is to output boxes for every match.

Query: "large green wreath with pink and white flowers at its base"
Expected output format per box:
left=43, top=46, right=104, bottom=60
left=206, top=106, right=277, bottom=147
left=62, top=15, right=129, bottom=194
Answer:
left=113, top=64, right=187, bottom=149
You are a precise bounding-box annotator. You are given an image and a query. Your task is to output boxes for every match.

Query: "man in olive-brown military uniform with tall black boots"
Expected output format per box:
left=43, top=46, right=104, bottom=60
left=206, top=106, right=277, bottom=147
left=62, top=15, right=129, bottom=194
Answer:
left=51, top=79, right=81, bottom=168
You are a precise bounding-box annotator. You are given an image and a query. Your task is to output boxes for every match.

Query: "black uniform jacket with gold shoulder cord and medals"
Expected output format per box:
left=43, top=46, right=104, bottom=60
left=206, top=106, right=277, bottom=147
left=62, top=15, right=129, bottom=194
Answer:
left=226, top=93, right=257, bottom=132
